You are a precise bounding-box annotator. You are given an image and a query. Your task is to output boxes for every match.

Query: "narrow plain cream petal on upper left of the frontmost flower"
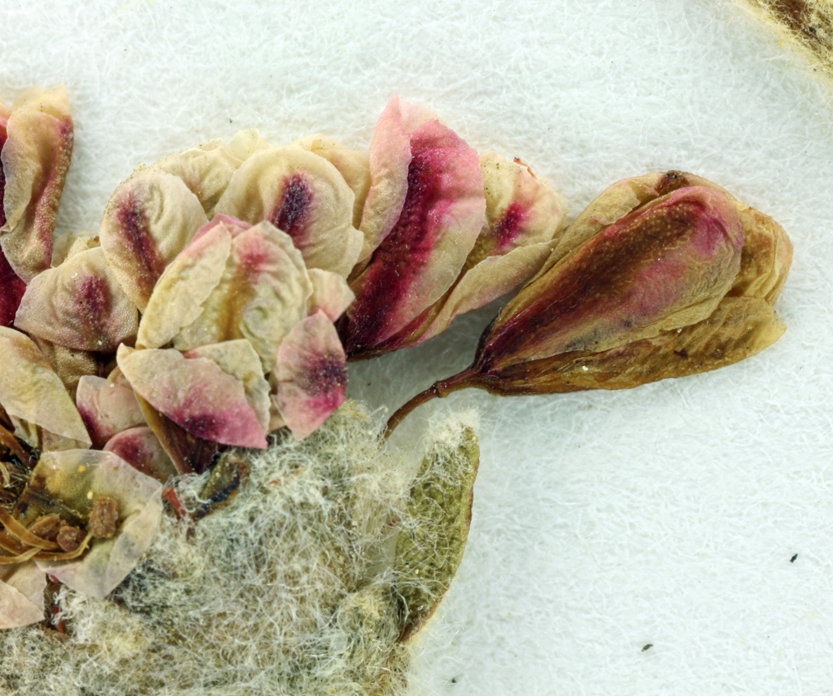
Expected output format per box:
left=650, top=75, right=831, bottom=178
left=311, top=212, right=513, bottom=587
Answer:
left=136, top=219, right=231, bottom=348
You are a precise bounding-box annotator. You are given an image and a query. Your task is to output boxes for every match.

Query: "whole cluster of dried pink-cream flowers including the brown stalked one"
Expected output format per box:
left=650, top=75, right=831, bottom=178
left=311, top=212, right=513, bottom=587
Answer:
left=0, top=81, right=791, bottom=668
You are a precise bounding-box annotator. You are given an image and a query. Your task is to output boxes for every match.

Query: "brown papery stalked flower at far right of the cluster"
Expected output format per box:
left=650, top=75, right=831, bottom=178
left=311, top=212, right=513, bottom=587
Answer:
left=388, top=172, right=792, bottom=431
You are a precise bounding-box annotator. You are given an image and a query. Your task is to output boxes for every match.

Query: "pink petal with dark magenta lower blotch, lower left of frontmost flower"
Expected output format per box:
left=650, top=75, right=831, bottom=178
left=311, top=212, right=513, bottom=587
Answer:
left=117, top=345, right=266, bottom=449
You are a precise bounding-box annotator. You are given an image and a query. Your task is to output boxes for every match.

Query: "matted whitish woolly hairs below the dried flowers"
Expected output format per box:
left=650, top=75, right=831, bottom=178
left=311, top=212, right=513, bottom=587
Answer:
left=0, top=402, right=480, bottom=696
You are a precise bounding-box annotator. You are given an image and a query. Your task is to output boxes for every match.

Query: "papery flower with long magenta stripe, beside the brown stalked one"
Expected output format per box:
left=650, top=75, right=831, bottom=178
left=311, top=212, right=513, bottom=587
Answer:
left=340, top=97, right=564, bottom=359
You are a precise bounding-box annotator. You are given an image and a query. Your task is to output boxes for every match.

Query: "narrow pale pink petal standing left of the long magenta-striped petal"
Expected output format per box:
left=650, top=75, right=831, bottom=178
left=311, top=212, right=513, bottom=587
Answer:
left=358, top=95, right=436, bottom=262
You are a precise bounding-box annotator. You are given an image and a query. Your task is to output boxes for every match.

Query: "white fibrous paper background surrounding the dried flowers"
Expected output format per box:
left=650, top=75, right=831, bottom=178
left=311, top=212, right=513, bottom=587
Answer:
left=0, top=0, right=833, bottom=696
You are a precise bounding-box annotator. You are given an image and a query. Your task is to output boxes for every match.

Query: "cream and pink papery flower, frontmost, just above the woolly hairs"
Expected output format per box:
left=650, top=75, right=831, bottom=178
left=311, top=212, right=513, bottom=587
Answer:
left=118, top=215, right=352, bottom=448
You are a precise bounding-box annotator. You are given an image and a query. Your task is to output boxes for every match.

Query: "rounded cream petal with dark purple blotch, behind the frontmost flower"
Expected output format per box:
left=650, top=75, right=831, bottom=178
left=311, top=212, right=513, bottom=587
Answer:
left=216, top=146, right=362, bottom=277
